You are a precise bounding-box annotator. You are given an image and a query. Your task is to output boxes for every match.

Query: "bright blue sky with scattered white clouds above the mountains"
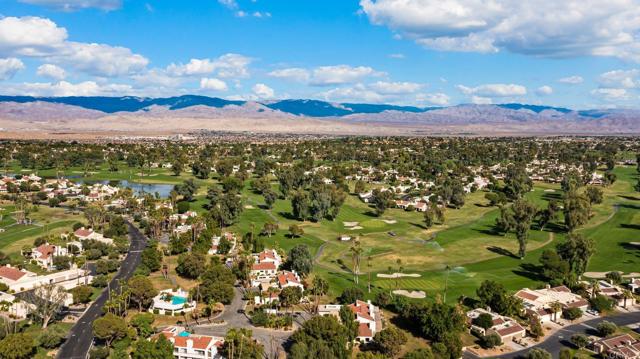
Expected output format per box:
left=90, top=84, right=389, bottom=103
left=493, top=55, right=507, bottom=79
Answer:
left=0, top=0, right=640, bottom=108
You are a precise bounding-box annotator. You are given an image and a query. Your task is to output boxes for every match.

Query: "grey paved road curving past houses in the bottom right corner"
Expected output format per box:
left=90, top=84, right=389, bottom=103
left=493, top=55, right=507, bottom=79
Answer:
left=464, top=312, right=640, bottom=359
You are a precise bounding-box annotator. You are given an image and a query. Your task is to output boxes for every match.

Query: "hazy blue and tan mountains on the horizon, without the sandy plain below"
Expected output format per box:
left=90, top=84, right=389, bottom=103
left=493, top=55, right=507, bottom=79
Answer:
left=0, top=95, right=640, bottom=134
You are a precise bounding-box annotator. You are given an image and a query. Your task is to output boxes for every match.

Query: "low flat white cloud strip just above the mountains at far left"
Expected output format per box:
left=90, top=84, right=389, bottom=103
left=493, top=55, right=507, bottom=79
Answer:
left=4, top=81, right=133, bottom=96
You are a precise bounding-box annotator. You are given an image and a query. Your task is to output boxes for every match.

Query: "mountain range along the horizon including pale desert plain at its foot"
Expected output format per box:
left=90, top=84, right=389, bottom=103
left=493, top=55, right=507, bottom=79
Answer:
left=0, top=95, right=640, bottom=135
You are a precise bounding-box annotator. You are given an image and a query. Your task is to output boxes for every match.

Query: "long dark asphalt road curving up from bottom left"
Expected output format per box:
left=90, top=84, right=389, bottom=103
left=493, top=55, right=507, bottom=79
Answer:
left=57, top=222, right=147, bottom=359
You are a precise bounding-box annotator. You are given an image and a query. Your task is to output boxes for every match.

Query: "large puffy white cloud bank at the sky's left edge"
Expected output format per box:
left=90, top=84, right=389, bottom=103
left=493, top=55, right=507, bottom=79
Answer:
left=0, top=17, right=149, bottom=77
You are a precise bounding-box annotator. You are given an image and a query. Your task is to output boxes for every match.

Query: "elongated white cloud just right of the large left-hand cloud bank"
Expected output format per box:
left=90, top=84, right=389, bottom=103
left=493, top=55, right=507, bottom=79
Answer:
left=167, top=54, right=253, bottom=78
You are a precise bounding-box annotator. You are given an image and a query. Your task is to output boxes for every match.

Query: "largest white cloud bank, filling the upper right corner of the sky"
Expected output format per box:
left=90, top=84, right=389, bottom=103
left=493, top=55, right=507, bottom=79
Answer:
left=360, top=0, right=640, bottom=61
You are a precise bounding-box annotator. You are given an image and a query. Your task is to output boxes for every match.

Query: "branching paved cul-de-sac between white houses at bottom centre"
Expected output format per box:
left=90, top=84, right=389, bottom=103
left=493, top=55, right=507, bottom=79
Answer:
left=192, top=287, right=306, bottom=358
